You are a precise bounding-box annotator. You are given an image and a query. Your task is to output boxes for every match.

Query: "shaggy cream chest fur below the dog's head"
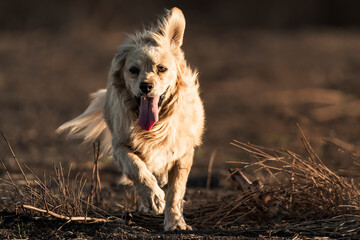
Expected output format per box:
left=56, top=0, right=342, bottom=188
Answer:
left=123, top=92, right=203, bottom=185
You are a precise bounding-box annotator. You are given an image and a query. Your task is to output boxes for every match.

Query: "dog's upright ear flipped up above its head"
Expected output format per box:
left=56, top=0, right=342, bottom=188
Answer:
left=160, top=7, right=185, bottom=47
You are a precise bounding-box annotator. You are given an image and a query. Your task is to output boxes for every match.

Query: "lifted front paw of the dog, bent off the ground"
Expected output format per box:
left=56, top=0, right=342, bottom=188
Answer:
left=139, top=186, right=165, bottom=214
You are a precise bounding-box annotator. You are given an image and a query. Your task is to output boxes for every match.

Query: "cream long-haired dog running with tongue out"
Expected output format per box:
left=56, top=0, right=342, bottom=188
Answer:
left=57, top=8, right=205, bottom=231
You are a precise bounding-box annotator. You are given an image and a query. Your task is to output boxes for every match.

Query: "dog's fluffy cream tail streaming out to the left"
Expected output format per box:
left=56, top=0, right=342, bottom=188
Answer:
left=56, top=89, right=112, bottom=156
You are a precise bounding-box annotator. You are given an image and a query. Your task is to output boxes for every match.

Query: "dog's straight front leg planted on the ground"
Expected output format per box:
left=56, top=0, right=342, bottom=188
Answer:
left=164, top=150, right=194, bottom=231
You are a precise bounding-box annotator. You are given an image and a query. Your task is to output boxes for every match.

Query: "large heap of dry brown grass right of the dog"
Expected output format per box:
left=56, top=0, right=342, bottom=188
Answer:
left=185, top=126, right=360, bottom=237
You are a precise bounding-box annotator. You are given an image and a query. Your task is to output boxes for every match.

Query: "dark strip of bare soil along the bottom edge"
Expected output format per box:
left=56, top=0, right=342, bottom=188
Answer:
left=0, top=212, right=294, bottom=239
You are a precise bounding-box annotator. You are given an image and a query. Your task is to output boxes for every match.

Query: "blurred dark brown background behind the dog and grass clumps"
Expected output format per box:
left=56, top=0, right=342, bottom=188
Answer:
left=0, top=0, right=360, bottom=186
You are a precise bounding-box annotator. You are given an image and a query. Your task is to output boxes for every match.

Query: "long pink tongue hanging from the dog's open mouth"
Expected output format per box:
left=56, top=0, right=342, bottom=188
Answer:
left=138, top=97, right=160, bottom=131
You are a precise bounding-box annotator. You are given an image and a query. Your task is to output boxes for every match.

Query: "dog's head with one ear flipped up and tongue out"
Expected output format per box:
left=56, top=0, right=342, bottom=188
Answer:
left=110, top=8, right=185, bottom=130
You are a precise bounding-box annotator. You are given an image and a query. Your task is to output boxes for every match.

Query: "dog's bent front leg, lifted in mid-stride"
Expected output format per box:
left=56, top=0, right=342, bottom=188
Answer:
left=114, top=145, right=165, bottom=214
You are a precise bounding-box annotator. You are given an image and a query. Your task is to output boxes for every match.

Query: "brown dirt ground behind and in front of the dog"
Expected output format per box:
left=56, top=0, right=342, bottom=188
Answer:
left=0, top=2, right=360, bottom=239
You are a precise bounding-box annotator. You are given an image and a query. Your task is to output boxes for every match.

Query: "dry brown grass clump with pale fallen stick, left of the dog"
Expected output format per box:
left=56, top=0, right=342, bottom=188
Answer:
left=0, top=133, right=115, bottom=225
